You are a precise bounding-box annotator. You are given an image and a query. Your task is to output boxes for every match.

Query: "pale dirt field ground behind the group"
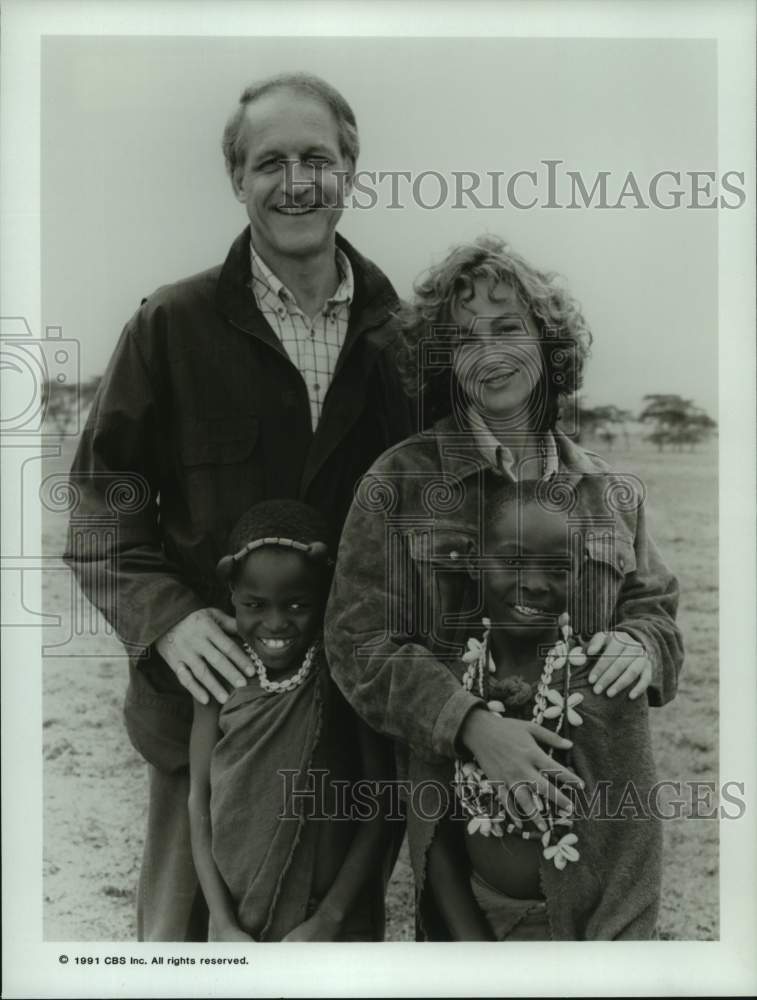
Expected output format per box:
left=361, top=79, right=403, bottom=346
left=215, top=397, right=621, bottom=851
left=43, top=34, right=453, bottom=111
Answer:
left=43, top=436, right=718, bottom=941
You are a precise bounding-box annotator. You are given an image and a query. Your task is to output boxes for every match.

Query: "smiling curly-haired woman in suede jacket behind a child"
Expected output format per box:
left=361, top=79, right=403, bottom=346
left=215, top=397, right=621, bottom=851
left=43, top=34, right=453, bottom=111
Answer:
left=326, top=237, right=682, bottom=939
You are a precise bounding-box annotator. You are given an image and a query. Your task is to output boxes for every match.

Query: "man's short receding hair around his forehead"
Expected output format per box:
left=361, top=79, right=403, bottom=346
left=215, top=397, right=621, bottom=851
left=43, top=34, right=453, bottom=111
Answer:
left=221, top=73, right=360, bottom=177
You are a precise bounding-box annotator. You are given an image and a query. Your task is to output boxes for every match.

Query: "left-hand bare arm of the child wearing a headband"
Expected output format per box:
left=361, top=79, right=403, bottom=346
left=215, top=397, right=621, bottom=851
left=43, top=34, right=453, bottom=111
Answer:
left=189, top=699, right=253, bottom=941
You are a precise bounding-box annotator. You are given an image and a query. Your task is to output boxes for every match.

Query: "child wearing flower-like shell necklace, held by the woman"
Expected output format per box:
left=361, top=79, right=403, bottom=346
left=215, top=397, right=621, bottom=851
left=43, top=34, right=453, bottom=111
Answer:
left=420, top=484, right=662, bottom=941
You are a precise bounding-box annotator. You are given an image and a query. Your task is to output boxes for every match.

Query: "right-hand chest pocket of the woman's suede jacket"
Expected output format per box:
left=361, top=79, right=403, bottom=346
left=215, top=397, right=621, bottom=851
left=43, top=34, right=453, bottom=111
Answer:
left=571, top=531, right=636, bottom=636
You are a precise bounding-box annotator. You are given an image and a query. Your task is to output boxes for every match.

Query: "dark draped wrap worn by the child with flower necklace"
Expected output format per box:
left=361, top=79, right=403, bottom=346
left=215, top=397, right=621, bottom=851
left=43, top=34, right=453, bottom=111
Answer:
left=407, top=664, right=662, bottom=941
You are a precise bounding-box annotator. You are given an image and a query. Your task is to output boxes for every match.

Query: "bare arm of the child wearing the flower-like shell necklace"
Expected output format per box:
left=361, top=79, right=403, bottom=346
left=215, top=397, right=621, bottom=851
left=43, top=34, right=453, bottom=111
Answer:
left=426, top=817, right=495, bottom=941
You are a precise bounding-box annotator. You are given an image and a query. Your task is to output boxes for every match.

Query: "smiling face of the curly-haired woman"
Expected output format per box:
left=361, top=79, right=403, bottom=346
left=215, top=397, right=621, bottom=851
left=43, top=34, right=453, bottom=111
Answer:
left=452, top=279, right=544, bottom=430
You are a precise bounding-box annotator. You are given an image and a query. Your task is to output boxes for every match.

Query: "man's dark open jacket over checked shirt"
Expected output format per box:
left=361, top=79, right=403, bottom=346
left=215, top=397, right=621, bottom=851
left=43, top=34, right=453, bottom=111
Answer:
left=65, top=228, right=416, bottom=770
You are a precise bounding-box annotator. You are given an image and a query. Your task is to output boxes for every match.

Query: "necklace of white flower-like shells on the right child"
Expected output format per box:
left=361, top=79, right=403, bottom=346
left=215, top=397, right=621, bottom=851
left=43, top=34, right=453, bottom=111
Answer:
left=455, top=612, right=586, bottom=871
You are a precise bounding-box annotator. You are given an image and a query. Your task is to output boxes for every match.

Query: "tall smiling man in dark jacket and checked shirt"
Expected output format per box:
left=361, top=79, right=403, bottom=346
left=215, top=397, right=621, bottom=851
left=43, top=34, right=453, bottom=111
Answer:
left=66, top=74, right=412, bottom=941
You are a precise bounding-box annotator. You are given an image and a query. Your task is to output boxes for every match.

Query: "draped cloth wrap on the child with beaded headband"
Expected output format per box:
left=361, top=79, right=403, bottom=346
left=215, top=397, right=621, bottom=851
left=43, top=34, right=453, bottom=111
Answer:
left=210, top=655, right=336, bottom=941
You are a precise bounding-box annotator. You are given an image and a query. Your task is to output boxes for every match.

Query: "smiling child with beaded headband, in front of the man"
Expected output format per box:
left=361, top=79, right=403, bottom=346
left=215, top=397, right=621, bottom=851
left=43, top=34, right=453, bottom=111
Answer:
left=189, top=500, right=387, bottom=941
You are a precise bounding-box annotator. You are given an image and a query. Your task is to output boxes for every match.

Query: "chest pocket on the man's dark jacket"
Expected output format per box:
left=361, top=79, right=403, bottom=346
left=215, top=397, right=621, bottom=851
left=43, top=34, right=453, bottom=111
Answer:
left=180, top=414, right=264, bottom=538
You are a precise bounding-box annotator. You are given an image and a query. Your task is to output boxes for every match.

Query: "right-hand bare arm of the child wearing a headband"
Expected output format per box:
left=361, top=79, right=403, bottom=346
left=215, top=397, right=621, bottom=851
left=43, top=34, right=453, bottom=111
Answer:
left=284, top=721, right=393, bottom=941
